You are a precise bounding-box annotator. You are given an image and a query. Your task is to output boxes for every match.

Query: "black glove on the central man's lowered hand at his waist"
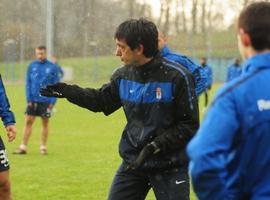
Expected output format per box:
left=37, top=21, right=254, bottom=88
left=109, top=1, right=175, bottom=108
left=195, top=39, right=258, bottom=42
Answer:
left=126, top=142, right=160, bottom=171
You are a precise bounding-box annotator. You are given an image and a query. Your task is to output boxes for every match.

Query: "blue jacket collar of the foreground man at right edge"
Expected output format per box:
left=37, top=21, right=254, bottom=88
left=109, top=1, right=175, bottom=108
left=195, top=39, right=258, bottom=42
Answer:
left=243, top=52, right=270, bottom=73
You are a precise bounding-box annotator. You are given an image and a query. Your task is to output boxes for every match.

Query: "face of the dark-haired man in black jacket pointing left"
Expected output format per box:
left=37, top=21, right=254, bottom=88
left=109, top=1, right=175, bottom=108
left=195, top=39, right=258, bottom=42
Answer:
left=115, top=39, right=139, bottom=65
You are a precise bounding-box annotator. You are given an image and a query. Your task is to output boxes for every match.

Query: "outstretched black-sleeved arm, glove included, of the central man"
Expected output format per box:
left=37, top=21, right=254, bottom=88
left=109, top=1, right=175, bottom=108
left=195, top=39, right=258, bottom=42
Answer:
left=41, top=72, right=121, bottom=115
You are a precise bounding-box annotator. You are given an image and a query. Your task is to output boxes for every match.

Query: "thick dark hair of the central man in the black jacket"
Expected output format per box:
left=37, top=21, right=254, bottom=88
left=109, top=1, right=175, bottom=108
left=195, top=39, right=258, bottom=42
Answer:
left=114, top=18, right=158, bottom=57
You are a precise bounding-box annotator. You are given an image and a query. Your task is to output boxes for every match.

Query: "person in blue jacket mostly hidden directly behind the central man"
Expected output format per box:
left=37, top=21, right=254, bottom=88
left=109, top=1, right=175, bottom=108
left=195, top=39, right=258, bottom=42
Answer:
left=158, top=31, right=208, bottom=96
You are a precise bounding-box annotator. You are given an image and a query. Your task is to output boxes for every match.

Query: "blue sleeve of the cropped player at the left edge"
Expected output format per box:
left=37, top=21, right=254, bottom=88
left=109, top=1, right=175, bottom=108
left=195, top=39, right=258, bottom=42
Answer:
left=0, top=76, right=15, bottom=126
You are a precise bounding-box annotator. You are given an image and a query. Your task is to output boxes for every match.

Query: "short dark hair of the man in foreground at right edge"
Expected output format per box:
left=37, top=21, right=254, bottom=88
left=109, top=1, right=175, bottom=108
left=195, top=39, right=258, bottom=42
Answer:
left=238, top=2, right=270, bottom=51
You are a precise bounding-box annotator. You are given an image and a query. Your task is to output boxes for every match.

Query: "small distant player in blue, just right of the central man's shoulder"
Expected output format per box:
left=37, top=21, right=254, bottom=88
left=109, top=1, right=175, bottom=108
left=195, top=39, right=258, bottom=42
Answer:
left=200, top=57, right=213, bottom=108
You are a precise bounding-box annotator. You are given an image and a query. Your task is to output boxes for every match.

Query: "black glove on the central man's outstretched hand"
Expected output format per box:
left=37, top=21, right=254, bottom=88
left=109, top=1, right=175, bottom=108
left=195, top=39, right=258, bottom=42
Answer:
left=39, top=83, right=67, bottom=98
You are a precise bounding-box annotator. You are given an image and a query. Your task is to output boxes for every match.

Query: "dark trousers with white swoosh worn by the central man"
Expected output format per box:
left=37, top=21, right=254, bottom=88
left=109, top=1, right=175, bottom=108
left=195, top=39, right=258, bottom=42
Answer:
left=108, top=165, right=189, bottom=200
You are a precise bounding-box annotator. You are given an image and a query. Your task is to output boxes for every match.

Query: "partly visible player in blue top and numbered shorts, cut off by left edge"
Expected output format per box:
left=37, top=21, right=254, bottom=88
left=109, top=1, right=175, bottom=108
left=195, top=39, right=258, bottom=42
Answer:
left=0, top=76, right=16, bottom=200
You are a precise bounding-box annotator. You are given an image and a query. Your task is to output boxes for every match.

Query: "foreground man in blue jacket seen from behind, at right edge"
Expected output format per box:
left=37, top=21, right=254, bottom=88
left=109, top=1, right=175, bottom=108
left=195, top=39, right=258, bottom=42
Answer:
left=188, top=2, right=270, bottom=200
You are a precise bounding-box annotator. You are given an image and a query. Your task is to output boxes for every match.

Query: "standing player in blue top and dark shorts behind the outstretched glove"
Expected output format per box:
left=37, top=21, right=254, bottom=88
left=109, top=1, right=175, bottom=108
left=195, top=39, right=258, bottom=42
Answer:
left=14, top=46, right=60, bottom=155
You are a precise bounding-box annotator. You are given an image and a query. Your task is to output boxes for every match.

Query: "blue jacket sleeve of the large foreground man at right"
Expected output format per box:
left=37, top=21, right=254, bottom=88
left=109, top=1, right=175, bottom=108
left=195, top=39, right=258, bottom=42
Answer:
left=187, top=89, right=238, bottom=200
